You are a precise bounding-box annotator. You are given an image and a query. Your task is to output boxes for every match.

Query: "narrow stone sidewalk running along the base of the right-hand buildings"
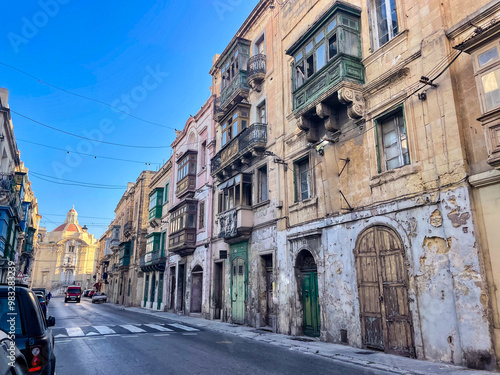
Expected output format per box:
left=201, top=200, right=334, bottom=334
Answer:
left=109, top=303, right=494, bottom=375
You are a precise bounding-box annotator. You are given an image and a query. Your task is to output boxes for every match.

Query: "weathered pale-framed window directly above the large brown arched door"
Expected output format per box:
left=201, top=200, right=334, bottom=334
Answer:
left=376, top=108, right=410, bottom=172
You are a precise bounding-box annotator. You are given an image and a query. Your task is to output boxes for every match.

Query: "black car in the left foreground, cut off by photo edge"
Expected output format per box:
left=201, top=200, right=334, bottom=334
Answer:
left=0, top=284, right=56, bottom=375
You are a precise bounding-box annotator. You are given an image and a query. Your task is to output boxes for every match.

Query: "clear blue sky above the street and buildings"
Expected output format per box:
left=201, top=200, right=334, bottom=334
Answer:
left=0, top=0, right=258, bottom=236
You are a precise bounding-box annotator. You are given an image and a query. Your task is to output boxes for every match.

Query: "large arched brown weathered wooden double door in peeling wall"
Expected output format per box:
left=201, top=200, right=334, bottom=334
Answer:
left=356, top=226, right=415, bottom=357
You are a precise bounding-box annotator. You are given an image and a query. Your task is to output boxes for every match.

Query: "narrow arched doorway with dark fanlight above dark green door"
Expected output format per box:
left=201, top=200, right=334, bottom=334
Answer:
left=296, top=250, right=321, bottom=337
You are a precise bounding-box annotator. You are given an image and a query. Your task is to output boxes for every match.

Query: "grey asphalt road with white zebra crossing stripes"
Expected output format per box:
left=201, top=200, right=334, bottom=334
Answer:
left=48, top=298, right=394, bottom=375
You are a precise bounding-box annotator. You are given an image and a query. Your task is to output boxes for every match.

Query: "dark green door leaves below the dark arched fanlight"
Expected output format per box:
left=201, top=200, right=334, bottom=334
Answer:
left=302, top=272, right=320, bottom=337
